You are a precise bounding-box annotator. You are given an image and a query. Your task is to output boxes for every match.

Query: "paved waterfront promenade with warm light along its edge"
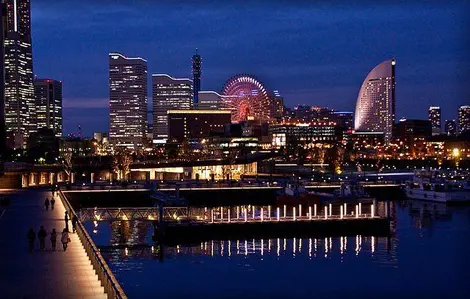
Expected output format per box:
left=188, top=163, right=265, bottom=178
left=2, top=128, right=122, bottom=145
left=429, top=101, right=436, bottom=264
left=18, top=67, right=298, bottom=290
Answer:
left=0, top=190, right=106, bottom=299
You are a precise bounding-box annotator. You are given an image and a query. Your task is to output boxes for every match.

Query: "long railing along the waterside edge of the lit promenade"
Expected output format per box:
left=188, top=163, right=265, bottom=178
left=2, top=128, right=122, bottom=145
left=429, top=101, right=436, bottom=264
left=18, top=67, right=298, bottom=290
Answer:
left=59, top=190, right=127, bottom=299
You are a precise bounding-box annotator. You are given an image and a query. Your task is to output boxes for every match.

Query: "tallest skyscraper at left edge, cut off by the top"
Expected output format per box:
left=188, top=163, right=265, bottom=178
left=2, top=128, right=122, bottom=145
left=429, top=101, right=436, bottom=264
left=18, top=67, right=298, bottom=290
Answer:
left=4, top=0, right=37, bottom=148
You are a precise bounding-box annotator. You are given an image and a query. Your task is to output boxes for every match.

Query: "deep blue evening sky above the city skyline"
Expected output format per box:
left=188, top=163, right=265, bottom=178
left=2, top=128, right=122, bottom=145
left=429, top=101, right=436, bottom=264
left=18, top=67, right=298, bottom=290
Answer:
left=32, top=0, right=470, bottom=135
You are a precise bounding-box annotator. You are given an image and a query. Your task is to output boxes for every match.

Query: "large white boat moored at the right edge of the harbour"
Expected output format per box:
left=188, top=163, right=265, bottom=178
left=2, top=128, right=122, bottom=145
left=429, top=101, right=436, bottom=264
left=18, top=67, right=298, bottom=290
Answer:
left=404, top=172, right=470, bottom=204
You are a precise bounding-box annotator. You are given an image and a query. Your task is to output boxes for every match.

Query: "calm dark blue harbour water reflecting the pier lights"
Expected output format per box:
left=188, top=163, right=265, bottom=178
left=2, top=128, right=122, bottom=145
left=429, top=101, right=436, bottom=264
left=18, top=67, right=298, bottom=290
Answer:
left=86, top=202, right=470, bottom=299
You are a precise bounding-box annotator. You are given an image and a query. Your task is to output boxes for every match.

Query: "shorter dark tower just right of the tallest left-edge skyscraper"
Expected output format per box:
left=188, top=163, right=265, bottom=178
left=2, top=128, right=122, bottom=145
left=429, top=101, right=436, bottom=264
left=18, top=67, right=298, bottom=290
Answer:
left=34, top=79, right=62, bottom=137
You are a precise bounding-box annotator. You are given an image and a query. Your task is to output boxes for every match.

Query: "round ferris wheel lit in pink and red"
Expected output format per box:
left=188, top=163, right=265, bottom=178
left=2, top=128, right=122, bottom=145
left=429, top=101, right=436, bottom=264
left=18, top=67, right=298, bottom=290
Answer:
left=222, top=74, right=271, bottom=122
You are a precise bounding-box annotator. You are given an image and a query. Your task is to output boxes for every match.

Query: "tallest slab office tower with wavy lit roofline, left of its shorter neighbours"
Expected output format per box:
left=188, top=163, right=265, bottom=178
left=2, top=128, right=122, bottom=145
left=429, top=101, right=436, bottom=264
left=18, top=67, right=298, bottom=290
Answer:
left=109, top=53, right=148, bottom=148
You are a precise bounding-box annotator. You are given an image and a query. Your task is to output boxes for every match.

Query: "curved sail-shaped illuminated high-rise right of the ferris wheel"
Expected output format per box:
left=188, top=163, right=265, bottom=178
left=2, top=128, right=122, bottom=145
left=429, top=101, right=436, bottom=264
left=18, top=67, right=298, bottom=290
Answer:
left=354, top=59, right=396, bottom=141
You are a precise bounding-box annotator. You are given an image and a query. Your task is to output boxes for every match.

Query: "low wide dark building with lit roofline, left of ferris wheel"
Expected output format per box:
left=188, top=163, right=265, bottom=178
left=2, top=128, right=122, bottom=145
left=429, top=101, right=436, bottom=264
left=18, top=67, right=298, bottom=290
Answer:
left=168, top=110, right=231, bottom=141
